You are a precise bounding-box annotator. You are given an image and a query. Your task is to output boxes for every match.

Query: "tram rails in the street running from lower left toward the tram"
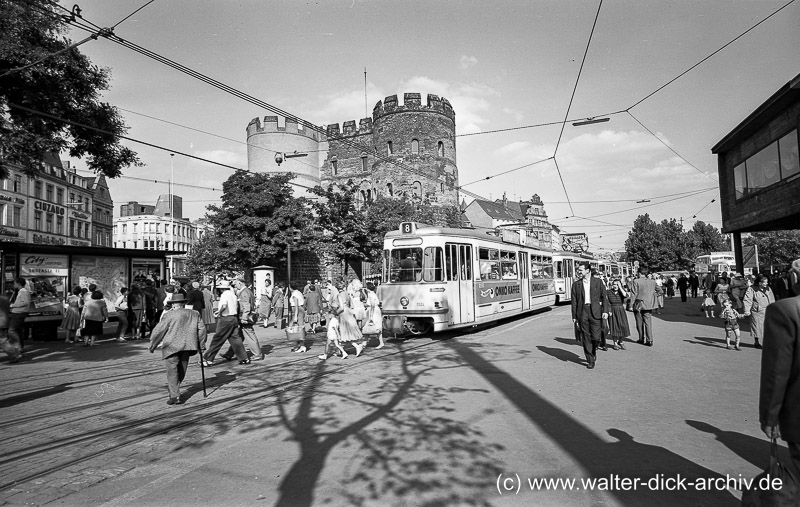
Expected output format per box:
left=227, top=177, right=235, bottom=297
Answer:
left=0, top=340, right=438, bottom=491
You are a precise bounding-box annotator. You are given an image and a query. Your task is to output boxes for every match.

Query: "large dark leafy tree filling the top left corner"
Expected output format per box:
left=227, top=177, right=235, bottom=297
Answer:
left=0, top=0, right=141, bottom=178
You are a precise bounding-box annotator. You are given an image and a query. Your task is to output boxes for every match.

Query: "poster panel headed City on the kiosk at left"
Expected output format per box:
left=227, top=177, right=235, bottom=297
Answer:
left=19, top=253, right=69, bottom=321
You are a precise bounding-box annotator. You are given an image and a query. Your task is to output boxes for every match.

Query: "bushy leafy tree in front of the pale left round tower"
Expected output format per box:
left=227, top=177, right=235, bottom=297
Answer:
left=189, top=171, right=312, bottom=274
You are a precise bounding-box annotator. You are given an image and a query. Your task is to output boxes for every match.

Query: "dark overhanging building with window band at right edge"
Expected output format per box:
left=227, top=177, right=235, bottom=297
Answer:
left=711, top=74, right=800, bottom=268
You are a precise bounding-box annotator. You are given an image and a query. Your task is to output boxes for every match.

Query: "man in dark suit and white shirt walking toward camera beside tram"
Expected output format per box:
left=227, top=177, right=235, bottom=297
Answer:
left=572, top=262, right=611, bottom=370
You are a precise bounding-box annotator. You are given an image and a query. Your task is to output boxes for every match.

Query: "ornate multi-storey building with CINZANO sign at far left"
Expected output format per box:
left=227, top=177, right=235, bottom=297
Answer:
left=0, top=155, right=98, bottom=246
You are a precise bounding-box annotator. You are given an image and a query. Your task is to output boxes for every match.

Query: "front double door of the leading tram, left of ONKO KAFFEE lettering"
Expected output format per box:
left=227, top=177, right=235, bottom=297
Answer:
left=445, top=243, right=475, bottom=324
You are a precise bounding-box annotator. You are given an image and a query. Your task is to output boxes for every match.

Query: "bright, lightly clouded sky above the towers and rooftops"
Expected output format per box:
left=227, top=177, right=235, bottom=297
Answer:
left=61, top=0, right=800, bottom=252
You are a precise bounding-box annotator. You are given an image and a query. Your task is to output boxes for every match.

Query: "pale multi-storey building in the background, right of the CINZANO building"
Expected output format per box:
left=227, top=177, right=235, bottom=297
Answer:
left=113, top=195, right=198, bottom=276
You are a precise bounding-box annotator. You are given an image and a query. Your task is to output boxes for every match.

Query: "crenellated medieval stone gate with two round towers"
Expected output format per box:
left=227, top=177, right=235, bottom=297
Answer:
left=247, top=93, right=458, bottom=212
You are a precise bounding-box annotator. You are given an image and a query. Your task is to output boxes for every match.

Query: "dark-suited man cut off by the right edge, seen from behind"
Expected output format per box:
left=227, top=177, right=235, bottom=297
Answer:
left=758, top=259, right=800, bottom=484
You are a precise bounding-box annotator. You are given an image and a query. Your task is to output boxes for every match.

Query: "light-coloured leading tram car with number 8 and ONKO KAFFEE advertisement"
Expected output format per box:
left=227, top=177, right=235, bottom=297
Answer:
left=378, top=222, right=555, bottom=335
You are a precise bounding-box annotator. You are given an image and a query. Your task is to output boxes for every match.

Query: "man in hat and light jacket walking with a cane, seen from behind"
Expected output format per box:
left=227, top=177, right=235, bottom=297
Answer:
left=150, top=294, right=206, bottom=405
